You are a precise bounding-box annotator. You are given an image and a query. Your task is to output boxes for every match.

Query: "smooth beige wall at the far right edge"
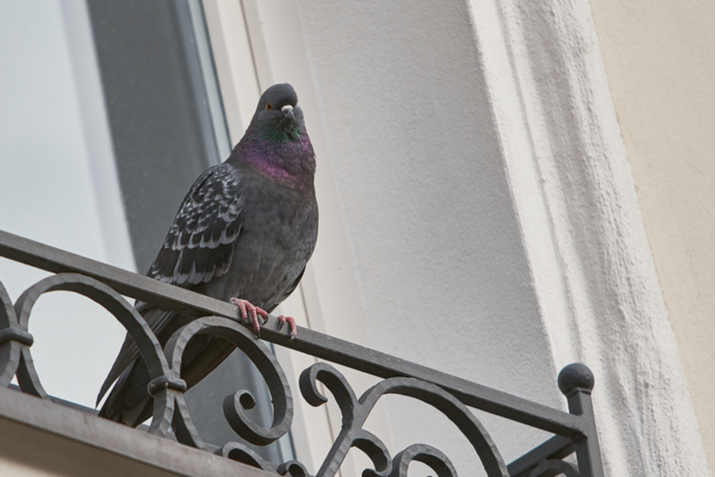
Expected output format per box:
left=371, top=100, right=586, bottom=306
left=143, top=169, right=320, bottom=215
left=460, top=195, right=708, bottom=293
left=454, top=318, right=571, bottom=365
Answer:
left=591, top=0, right=714, bottom=472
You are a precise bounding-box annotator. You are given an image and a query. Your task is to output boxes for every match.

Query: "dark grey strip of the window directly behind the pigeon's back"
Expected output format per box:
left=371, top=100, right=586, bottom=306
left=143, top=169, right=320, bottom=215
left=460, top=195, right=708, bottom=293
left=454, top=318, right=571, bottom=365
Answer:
left=88, top=0, right=290, bottom=462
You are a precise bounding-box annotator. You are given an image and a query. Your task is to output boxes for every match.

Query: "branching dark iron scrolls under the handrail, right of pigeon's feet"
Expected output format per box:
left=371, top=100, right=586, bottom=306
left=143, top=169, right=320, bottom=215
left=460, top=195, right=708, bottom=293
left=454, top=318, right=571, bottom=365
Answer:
left=300, top=363, right=510, bottom=477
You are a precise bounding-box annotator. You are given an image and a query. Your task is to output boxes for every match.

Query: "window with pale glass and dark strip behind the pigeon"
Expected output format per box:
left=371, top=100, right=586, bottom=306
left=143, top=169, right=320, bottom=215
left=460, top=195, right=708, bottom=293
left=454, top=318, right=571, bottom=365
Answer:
left=0, top=0, right=293, bottom=462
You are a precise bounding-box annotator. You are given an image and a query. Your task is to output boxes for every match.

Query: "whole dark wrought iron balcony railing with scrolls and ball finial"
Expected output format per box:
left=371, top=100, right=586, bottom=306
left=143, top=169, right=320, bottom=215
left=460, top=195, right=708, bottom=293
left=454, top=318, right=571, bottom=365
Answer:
left=0, top=231, right=604, bottom=477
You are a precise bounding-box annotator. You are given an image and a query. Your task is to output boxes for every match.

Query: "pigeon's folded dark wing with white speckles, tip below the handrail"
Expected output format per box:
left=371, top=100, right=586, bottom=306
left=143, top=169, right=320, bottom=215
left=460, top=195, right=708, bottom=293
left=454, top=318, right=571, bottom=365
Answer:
left=97, top=163, right=243, bottom=403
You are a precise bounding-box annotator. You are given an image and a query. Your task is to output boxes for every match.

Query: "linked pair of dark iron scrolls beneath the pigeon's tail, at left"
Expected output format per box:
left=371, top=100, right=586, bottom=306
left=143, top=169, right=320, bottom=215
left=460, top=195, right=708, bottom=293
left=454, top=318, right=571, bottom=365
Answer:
left=0, top=273, right=309, bottom=477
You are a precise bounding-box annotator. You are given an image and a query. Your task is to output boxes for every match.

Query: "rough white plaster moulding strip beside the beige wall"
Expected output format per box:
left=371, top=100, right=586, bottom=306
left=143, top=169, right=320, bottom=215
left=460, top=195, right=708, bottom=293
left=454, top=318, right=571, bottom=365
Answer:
left=472, top=0, right=708, bottom=476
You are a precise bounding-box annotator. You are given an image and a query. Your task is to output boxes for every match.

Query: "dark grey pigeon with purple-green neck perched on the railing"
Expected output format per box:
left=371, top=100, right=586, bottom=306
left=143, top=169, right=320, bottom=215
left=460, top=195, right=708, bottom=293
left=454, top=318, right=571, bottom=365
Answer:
left=97, top=84, right=318, bottom=427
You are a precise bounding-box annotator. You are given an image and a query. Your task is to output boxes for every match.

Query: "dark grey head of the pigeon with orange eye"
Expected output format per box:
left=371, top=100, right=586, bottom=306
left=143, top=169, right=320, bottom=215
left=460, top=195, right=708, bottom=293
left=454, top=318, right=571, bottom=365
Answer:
left=252, top=83, right=303, bottom=140
